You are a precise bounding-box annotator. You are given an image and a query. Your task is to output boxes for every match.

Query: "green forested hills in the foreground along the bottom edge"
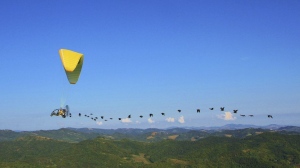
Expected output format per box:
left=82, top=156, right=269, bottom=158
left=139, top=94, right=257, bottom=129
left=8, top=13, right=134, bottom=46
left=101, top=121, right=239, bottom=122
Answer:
left=0, top=132, right=300, bottom=167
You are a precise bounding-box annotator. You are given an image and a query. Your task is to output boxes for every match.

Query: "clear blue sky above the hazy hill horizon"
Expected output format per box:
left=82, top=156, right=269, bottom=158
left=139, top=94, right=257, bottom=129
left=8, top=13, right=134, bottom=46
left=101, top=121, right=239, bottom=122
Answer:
left=0, top=0, right=300, bottom=130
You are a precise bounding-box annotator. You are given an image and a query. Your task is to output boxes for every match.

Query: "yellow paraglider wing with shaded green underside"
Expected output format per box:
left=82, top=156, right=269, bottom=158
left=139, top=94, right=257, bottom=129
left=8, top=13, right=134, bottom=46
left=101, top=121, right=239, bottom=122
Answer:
left=59, top=49, right=84, bottom=84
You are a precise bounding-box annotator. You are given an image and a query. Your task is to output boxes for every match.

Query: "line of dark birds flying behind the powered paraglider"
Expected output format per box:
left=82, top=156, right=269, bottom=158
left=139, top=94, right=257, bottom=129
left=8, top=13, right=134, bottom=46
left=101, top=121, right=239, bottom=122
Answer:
left=63, top=107, right=273, bottom=121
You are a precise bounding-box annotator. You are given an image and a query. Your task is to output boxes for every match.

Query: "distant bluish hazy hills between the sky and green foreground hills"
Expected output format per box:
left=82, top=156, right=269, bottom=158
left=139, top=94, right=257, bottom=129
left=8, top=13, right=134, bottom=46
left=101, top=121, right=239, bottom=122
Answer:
left=0, top=126, right=300, bottom=143
